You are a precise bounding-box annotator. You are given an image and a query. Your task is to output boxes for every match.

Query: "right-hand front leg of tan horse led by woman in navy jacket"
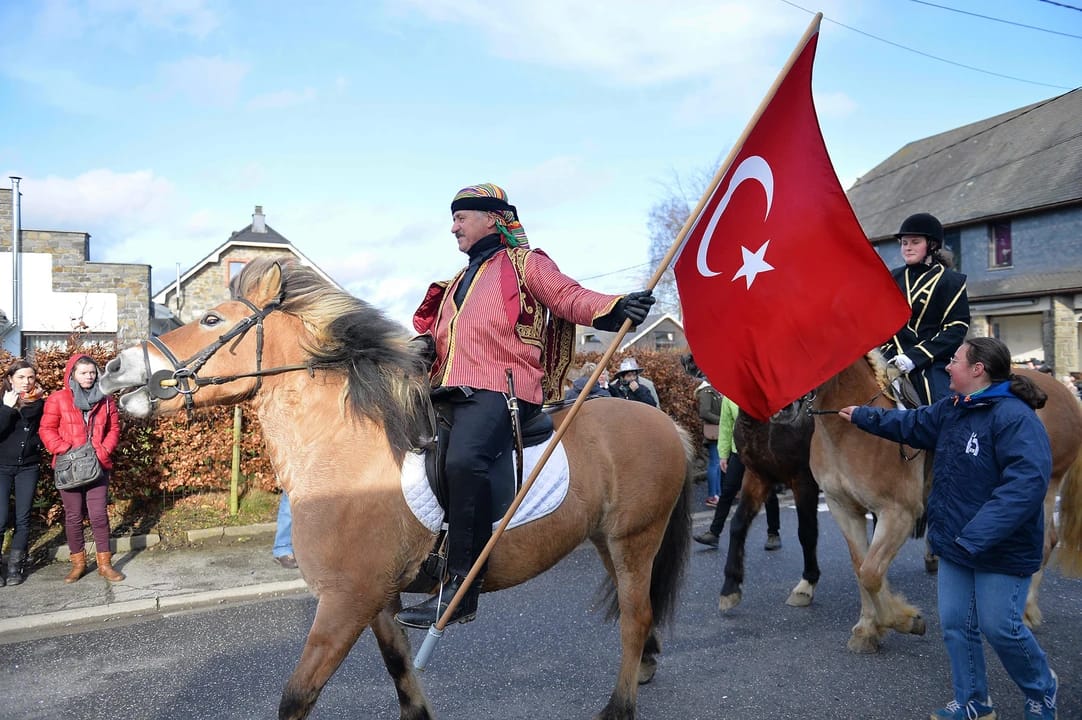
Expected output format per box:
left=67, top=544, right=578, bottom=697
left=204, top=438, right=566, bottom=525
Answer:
left=858, top=508, right=925, bottom=634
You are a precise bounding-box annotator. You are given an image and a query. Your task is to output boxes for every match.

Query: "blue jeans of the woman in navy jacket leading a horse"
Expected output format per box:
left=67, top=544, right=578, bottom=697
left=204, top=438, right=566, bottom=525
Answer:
left=938, top=558, right=1052, bottom=705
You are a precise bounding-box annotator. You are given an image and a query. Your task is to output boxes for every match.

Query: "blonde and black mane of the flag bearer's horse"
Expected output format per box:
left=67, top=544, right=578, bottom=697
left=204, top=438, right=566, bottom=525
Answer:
left=233, top=257, right=431, bottom=461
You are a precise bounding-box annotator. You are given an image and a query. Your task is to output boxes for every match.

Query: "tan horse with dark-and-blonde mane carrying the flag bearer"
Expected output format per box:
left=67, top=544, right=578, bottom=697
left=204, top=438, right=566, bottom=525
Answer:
left=102, top=260, right=694, bottom=720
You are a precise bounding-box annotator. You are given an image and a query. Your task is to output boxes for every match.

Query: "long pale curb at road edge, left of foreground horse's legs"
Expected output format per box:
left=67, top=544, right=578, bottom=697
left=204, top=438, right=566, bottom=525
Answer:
left=0, top=579, right=308, bottom=637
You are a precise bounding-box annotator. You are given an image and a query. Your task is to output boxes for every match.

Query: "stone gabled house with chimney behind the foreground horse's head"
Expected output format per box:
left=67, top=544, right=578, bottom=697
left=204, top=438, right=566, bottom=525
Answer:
left=154, top=205, right=341, bottom=325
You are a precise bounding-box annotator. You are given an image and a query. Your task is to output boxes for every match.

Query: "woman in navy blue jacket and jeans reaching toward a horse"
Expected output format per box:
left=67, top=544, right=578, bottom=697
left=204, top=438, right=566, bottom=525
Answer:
left=840, top=338, right=1057, bottom=720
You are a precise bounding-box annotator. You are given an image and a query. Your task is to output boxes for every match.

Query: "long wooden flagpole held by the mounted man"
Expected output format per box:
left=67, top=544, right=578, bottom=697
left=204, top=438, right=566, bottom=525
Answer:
left=413, top=13, right=822, bottom=670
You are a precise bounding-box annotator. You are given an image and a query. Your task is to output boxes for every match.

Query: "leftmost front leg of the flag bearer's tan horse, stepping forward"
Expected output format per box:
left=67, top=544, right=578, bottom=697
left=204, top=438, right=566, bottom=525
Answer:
left=278, top=592, right=380, bottom=720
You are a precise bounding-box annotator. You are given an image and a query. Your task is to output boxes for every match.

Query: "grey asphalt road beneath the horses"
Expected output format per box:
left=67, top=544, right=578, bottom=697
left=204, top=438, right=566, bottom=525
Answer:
left=0, top=509, right=1082, bottom=720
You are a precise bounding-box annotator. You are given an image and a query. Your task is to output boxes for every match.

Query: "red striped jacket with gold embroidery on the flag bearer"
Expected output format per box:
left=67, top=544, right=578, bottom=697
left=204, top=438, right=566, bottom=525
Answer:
left=413, top=248, right=621, bottom=404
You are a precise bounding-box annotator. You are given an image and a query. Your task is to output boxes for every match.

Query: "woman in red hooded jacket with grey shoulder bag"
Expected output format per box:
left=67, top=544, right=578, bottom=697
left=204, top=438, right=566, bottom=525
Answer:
left=38, top=353, right=124, bottom=582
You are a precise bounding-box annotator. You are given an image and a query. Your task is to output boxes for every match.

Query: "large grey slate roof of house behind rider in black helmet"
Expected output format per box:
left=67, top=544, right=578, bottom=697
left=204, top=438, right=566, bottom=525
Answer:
left=847, top=88, right=1082, bottom=240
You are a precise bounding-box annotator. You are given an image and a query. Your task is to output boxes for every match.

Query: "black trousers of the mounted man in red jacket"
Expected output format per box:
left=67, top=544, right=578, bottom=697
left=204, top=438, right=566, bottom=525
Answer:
left=447, top=388, right=540, bottom=576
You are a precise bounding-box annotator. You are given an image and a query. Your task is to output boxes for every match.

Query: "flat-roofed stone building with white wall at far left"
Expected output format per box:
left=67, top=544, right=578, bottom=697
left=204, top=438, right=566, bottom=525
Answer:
left=0, top=178, right=151, bottom=356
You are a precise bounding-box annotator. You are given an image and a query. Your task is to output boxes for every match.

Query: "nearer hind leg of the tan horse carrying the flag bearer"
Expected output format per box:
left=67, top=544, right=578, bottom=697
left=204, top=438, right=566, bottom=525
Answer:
left=594, top=526, right=663, bottom=720
